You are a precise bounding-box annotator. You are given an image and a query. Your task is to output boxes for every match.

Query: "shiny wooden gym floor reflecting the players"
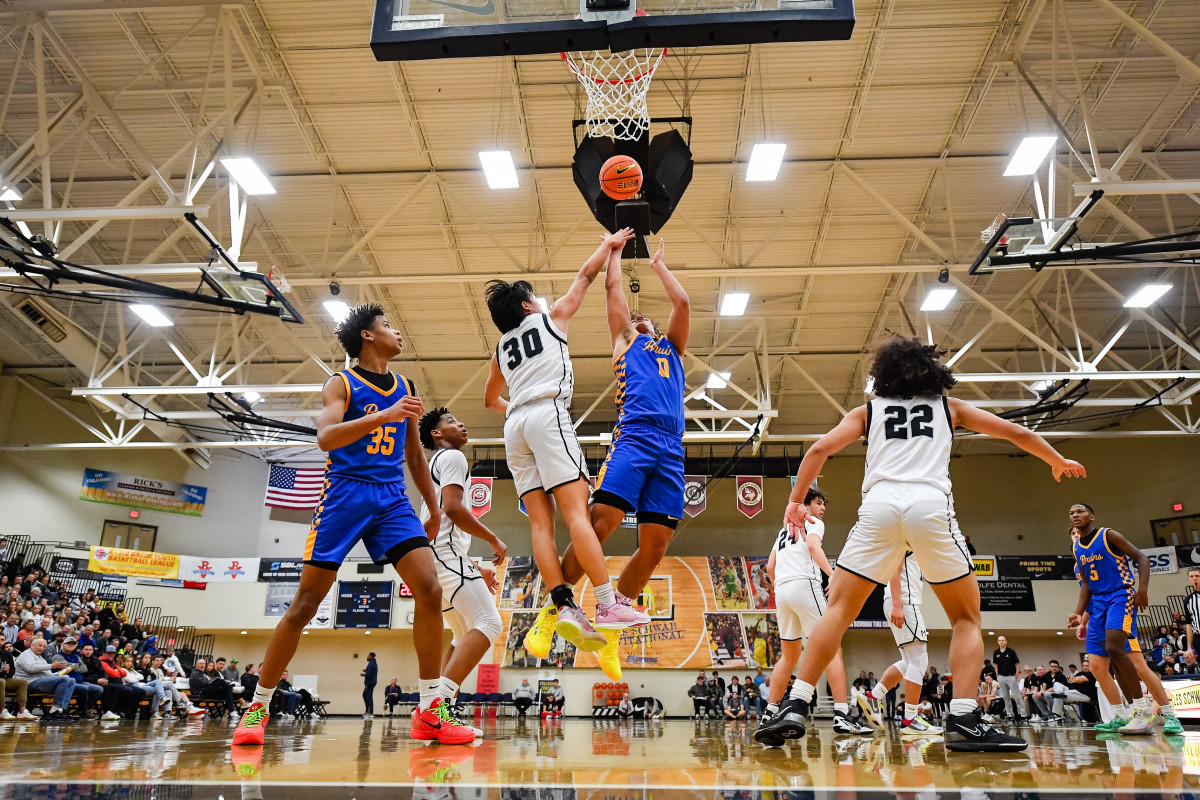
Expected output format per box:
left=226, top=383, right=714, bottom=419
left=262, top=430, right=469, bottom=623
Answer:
left=0, top=717, right=1200, bottom=800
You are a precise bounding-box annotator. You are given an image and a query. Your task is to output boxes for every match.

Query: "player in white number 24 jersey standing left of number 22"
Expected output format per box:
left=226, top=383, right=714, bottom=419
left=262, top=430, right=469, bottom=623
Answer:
left=760, top=489, right=871, bottom=747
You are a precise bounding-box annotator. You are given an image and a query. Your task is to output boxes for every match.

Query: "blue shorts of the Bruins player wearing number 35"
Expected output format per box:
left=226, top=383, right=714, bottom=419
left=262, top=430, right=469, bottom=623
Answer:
left=304, top=475, right=430, bottom=570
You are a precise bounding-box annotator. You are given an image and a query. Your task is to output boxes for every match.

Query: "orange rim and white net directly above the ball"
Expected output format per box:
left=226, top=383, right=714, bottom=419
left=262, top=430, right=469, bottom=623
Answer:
left=562, top=8, right=667, bottom=142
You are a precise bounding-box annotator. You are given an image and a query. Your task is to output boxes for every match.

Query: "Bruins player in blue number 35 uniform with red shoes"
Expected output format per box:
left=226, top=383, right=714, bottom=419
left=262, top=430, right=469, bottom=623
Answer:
left=233, top=303, right=475, bottom=747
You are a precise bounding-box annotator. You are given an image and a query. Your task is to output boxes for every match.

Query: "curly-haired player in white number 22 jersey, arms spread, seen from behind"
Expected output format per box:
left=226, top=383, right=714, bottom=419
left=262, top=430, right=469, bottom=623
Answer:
left=770, top=337, right=1085, bottom=752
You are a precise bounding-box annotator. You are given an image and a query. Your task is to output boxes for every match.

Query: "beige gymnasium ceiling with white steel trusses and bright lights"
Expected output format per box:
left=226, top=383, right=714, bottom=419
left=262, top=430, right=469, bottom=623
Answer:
left=0, top=0, right=1200, bottom=456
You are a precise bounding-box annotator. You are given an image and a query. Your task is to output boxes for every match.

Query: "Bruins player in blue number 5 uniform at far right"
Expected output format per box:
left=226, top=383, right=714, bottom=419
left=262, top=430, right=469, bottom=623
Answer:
left=1067, top=503, right=1183, bottom=735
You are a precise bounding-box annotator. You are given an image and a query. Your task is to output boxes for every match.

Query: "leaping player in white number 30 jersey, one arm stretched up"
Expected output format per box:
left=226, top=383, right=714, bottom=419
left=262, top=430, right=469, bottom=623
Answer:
left=484, top=228, right=634, bottom=651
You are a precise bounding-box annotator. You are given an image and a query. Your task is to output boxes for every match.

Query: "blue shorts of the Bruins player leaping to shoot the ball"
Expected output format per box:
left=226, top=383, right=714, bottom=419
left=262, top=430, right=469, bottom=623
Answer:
left=596, top=425, right=684, bottom=522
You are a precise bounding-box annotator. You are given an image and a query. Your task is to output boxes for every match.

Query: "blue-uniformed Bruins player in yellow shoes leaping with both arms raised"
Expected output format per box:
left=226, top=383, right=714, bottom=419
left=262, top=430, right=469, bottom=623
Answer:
left=526, top=235, right=691, bottom=680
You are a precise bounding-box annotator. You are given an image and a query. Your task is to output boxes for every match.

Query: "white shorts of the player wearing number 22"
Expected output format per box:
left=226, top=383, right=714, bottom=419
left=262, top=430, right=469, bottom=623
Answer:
left=838, top=482, right=974, bottom=585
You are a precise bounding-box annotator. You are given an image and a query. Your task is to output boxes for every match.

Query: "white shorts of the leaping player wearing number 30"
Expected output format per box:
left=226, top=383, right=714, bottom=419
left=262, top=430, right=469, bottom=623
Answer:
left=504, top=401, right=588, bottom=497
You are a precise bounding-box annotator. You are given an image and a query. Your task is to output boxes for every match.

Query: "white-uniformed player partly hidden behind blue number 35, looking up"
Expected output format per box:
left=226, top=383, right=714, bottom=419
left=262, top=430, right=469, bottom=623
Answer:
left=418, top=408, right=508, bottom=736
